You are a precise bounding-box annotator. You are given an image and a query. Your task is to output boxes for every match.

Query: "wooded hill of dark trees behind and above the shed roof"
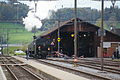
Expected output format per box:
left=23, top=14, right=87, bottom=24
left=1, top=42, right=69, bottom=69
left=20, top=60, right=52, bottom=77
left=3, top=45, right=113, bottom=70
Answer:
left=41, top=7, right=120, bottom=30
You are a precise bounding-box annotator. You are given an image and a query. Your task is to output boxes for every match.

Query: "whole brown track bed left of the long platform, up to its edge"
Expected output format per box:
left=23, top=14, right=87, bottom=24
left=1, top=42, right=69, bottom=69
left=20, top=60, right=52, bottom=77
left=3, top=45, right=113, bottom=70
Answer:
left=0, top=57, right=56, bottom=80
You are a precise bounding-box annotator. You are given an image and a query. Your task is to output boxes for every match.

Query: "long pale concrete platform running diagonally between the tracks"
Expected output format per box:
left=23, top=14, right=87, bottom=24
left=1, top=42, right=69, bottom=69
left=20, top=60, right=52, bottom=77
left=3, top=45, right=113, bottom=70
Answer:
left=13, top=56, right=89, bottom=80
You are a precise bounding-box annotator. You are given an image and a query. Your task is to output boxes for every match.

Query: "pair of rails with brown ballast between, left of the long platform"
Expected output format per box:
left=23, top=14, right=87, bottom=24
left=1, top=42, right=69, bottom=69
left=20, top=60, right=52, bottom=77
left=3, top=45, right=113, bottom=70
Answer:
left=1, top=58, right=43, bottom=80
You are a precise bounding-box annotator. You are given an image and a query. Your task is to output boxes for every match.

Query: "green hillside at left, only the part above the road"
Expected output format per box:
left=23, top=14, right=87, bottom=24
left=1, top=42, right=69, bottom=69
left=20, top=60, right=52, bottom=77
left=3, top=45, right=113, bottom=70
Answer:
left=0, top=23, right=42, bottom=44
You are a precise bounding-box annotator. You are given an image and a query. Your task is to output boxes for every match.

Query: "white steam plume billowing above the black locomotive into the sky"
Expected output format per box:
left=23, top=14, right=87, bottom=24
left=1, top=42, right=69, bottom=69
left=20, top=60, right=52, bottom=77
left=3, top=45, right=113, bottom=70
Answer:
left=23, top=1, right=56, bottom=31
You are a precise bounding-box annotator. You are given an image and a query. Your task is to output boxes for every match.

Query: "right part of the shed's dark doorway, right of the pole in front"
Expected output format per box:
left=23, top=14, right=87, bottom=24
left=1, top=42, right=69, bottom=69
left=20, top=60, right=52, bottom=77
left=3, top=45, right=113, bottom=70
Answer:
left=77, top=32, right=94, bottom=57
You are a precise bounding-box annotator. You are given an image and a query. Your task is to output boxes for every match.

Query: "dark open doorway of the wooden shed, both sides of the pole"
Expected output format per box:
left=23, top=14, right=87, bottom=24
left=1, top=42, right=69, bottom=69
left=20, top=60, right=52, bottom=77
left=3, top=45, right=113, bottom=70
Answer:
left=60, top=32, right=95, bottom=57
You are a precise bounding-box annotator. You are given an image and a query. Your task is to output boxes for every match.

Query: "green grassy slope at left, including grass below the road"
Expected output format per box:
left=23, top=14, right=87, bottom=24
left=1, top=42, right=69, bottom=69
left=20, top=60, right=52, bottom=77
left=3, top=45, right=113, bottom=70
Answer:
left=0, top=23, right=42, bottom=55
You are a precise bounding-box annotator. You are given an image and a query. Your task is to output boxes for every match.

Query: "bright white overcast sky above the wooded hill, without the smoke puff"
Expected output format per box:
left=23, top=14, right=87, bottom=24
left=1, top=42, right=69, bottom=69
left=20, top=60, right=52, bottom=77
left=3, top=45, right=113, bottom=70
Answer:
left=21, top=0, right=120, bottom=19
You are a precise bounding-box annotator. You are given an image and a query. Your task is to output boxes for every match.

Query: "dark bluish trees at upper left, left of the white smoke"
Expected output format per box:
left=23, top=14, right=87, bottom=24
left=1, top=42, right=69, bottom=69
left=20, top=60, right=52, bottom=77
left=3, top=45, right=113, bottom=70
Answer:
left=0, top=0, right=29, bottom=44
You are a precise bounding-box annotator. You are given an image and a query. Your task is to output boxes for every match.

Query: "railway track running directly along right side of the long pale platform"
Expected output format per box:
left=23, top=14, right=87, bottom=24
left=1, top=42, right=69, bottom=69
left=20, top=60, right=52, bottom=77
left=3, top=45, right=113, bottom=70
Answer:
left=36, top=59, right=119, bottom=80
